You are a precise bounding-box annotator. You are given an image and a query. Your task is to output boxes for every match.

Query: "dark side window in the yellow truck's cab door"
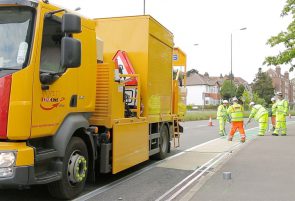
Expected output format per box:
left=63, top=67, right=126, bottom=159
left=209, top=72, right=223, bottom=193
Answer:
left=40, top=18, right=64, bottom=73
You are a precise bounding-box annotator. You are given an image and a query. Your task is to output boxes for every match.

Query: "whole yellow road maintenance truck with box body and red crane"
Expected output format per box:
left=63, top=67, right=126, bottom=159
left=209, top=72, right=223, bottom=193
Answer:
left=0, top=0, right=185, bottom=199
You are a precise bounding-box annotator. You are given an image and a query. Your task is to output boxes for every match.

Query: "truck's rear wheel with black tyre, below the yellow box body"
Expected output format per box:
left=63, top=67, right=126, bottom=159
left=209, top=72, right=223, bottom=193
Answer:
left=153, top=125, right=170, bottom=160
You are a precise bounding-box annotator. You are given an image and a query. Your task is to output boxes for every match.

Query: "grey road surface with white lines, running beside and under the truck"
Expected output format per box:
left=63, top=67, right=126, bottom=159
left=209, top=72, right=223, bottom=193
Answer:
left=0, top=118, right=292, bottom=201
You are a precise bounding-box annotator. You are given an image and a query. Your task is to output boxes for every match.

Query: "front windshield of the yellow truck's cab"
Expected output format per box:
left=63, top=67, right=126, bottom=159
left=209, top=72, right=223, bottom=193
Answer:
left=0, top=7, right=34, bottom=71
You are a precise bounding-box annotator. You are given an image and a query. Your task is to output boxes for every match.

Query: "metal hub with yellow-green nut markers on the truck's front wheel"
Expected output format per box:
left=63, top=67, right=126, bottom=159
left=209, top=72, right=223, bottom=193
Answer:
left=68, top=152, right=87, bottom=183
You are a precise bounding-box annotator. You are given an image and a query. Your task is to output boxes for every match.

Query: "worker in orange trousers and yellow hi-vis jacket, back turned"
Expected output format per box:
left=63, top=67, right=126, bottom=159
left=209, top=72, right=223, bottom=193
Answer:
left=227, top=97, right=246, bottom=142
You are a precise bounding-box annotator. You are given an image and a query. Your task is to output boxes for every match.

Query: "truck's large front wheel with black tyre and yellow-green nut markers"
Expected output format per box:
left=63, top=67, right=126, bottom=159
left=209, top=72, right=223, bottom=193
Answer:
left=48, top=137, right=88, bottom=199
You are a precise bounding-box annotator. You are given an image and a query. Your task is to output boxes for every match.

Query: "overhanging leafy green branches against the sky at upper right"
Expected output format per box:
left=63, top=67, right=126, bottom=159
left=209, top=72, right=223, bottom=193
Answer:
left=264, top=0, right=295, bottom=71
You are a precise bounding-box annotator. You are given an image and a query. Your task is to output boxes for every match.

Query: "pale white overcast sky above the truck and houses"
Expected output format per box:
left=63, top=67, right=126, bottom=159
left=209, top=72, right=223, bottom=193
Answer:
left=49, top=0, right=294, bottom=83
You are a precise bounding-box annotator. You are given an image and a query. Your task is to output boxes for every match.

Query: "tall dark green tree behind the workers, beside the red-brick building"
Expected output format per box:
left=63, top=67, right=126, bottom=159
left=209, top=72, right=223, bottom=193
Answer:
left=252, top=68, right=274, bottom=104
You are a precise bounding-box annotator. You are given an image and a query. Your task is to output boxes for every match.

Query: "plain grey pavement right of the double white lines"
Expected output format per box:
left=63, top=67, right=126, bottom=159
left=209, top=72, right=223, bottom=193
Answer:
left=180, top=122, right=295, bottom=201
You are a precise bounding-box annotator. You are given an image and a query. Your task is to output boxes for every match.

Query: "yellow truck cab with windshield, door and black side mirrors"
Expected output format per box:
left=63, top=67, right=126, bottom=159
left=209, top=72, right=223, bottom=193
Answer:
left=0, top=0, right=96, bottom=197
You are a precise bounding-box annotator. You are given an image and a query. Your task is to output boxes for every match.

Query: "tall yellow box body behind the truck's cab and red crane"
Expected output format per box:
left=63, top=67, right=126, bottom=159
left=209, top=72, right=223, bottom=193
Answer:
left=96, top=16, right=173, bottom=123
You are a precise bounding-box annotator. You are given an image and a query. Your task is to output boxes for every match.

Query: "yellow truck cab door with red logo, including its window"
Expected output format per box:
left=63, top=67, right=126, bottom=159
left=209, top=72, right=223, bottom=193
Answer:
left=31, top=9, right=78, bottom=138
